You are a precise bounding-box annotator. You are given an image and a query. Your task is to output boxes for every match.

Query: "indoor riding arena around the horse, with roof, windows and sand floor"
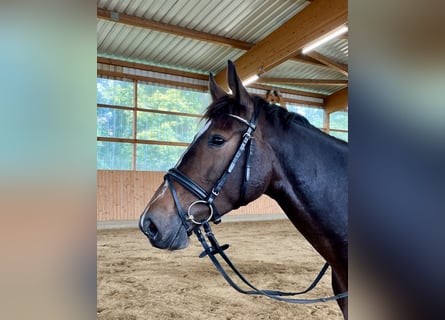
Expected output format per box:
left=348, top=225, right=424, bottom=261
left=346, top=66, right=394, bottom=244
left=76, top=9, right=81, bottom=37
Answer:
left=97, top=0, right=348, bottom=320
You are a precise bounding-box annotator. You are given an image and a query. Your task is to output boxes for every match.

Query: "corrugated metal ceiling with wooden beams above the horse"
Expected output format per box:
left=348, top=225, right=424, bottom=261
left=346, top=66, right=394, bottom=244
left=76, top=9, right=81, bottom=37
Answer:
left=97, top=0, right=348, bottom=101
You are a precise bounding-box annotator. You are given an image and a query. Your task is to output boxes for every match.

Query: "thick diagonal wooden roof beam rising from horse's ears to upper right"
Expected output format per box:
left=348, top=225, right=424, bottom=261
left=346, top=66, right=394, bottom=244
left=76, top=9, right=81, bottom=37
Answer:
left=215, top=0, right=348, bottom=89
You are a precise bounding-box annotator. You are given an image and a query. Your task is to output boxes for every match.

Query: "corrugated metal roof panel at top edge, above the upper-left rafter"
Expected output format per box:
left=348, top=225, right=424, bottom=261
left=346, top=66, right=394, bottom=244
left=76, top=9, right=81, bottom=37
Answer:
left=98, top=0, right=308, bottom=43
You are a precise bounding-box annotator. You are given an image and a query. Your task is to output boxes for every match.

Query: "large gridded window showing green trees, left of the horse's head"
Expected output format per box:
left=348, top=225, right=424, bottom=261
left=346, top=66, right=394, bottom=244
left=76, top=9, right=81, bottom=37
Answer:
left=97, top=78, right=210, bottom=171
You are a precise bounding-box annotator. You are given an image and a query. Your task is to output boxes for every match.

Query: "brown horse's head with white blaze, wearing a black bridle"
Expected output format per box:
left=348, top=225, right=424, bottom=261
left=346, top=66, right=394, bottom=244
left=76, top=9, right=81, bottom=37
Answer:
left=139, top=61, right=273, bottom=250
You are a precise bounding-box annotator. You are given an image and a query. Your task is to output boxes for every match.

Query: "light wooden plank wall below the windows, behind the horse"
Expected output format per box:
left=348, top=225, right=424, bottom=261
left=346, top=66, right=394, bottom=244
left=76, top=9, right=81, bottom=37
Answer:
left=97, top=170, right=283, bottom=221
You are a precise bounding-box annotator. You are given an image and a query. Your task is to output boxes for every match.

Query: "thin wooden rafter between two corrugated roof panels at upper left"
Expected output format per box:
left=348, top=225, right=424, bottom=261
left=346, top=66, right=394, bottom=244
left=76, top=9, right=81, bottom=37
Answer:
left=97, top=8, right=253, bottom=50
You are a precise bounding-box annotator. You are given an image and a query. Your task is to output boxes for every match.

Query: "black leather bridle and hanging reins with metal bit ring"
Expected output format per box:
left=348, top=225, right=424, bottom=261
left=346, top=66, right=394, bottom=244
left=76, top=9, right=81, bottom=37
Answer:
left=164, top=108, right=348, bottom=304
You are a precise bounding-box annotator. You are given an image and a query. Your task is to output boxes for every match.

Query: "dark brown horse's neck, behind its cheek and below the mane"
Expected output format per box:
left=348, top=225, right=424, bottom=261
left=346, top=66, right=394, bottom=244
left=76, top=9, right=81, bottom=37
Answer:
left=266, top=120, right=348, bottom=264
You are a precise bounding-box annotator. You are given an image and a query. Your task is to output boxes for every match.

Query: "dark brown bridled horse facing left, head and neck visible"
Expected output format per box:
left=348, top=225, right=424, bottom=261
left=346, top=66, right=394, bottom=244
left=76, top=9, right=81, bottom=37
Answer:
left=139, top=61, right=348, bottom=319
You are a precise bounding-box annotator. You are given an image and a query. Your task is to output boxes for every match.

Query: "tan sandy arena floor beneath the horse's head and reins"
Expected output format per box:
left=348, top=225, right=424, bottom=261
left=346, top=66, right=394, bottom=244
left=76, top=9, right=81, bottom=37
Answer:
left=97, top=220, right=342, bottom=320
